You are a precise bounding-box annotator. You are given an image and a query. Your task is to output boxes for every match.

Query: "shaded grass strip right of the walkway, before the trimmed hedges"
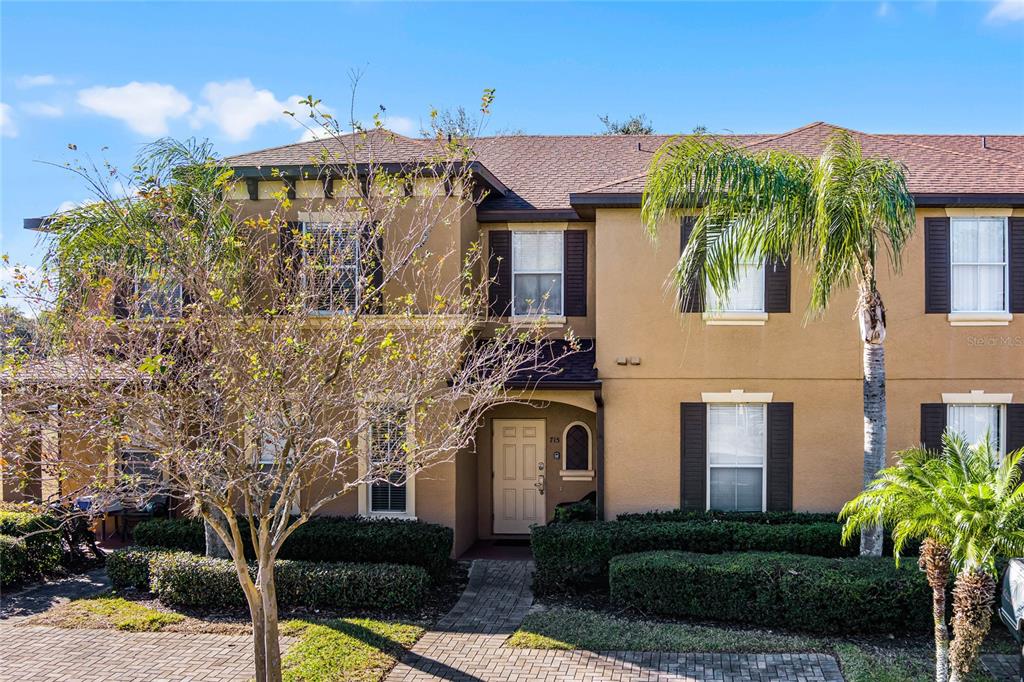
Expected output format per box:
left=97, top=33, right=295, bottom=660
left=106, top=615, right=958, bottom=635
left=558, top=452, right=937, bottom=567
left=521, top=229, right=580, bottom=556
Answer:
left=506, top=606, right=1002, bottom=682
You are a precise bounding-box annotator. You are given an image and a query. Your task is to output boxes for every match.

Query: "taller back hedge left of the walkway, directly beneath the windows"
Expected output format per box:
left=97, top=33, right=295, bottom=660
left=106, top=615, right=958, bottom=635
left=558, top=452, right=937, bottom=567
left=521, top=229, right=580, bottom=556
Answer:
left=134, top=516, right=455, bottom=581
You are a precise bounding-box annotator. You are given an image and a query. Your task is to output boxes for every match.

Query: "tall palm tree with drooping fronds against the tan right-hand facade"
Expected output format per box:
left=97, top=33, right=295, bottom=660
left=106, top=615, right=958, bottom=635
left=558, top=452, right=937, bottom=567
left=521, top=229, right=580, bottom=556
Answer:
left=641, top=131, right=914, bottom=556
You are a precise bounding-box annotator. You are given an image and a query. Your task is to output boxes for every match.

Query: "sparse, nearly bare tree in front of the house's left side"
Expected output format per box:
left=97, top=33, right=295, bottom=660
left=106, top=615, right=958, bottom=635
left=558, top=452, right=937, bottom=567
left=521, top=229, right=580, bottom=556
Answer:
left=0, top=94, right=572, bottom=682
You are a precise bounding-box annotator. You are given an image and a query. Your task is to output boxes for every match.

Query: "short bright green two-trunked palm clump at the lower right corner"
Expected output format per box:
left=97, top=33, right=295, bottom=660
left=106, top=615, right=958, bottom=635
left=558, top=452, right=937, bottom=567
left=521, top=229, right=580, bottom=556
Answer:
left=841, top=432, right=1024, bottom=682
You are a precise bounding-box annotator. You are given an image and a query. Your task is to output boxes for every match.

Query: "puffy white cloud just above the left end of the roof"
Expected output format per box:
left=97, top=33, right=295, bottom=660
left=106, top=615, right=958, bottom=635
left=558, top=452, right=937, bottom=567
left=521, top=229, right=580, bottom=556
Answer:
left=191, top=78, right=300, bottom=141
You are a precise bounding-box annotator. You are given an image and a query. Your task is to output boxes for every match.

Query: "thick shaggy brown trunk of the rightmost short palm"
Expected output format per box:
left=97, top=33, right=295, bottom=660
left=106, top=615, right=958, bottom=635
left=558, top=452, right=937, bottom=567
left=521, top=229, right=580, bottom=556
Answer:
left=949, top=569, right=995, bottom=682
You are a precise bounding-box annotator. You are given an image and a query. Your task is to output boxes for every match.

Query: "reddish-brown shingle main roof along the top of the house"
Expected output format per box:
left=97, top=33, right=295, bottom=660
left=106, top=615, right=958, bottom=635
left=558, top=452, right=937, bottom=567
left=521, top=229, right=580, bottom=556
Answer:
left=227, top=123, right=1024, bottom=211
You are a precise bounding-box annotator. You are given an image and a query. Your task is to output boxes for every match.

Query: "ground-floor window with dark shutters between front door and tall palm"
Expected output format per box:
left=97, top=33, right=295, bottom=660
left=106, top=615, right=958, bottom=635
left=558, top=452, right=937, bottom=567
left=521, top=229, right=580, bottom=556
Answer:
left=708, top=402, right=767, bottom=511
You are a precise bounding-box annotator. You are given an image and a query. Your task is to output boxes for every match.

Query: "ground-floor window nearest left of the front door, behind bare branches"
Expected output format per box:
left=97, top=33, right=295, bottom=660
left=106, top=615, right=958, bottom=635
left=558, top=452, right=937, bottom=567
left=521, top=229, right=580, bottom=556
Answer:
left=368, top=409, right=412, bottom=514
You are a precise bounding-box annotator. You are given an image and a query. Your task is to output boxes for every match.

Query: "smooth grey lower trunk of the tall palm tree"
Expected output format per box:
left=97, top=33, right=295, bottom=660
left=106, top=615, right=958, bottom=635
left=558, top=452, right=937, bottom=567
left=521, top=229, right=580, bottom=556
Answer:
left=860, top=343, right=889, bottom=556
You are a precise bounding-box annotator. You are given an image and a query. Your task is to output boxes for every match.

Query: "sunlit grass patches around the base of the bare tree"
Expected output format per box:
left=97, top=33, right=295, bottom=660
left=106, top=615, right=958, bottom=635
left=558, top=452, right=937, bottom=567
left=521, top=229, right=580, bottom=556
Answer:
left=25, top=594, right=424, bottom=682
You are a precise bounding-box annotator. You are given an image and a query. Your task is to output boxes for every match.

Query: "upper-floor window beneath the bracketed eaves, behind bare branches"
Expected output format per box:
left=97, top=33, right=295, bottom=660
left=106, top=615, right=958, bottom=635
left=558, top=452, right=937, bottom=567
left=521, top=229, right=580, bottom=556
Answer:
left=302, top=222, right=361, bottom=312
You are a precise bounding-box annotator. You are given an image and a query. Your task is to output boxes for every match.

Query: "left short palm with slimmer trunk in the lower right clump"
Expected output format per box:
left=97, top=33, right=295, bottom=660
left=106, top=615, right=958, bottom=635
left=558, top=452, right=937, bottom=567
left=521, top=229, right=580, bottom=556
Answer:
left=840, top=447, right=952, bottom=682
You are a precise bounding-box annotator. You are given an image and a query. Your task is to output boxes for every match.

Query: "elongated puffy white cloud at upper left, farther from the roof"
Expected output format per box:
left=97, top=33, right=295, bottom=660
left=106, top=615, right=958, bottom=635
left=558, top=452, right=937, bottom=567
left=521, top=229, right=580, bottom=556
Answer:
left=78, top=81, right=191, bottom=135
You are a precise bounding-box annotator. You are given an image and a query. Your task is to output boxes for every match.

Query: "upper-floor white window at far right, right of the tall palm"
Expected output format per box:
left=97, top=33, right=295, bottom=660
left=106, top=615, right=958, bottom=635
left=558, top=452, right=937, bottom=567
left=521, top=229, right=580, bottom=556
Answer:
left=949, top=218, right=1007, bottom=312
